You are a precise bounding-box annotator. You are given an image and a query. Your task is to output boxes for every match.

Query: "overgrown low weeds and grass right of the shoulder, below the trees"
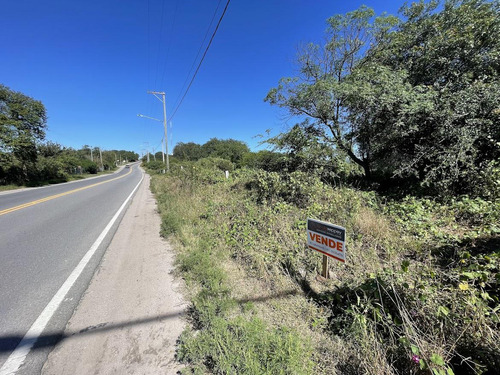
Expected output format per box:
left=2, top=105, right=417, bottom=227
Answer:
left=149, top=169, right=500, bottom=374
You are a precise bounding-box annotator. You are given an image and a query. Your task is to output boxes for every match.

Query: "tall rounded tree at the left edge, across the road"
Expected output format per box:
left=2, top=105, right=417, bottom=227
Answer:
left=0, top=85, right=47, bottom=166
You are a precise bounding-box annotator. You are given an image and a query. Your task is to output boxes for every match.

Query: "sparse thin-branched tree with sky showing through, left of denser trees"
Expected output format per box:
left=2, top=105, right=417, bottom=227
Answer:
left=266, top=6, right=397, bottom=177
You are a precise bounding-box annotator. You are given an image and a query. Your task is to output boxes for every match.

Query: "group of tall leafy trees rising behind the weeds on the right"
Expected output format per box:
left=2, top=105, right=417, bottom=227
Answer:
left=265, top=0, right=500, bottom=200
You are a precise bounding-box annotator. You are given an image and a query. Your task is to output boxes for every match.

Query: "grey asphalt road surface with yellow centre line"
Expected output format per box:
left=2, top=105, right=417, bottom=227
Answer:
left=0, top=164, right=142, bottom=374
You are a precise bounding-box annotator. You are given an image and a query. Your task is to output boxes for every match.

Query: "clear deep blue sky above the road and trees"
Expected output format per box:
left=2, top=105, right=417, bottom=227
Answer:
left=0, top=0, right=403, bottom=153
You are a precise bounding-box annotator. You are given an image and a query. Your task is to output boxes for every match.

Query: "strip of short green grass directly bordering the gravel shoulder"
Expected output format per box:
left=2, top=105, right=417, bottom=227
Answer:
left=152, top=176, right=313, bottom=375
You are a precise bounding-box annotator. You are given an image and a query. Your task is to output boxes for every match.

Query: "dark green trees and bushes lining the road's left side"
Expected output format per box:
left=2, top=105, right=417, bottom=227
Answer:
left=0, top=85, right=139, bottom=190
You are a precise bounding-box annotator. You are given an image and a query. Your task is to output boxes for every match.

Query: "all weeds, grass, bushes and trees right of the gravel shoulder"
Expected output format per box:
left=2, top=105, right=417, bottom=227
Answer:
left=149, top=0, right=500, bottom=375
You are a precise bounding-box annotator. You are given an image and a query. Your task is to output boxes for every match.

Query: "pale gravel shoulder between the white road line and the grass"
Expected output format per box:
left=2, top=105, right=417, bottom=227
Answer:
left=42, top=175, right=187, bottom=375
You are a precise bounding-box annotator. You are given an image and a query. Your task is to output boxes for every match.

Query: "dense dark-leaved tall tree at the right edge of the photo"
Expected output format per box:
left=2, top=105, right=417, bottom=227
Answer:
left=366, top=0, right=500, bottom=192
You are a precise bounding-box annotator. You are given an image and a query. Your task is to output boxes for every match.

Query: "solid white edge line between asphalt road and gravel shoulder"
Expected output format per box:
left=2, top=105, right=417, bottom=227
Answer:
left=0, top=174, right=144, bottom=375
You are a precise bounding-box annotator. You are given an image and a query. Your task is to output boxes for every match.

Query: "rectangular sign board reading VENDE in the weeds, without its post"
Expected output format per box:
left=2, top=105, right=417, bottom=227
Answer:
left=307, top=219, right=345, bottom=262
